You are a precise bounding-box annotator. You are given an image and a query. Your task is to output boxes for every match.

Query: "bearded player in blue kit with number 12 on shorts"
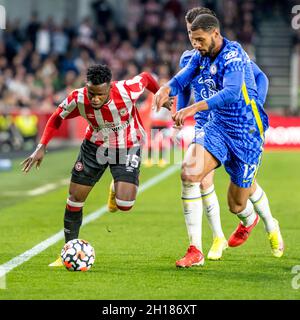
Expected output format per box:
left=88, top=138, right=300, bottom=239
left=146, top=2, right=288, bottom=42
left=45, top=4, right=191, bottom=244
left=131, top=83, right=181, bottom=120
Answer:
left=154, top=14, right=283, bottom=267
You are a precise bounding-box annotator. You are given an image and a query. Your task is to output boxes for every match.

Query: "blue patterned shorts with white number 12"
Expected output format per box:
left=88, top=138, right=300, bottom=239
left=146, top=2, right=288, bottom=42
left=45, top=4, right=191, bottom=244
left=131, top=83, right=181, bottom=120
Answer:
left=192, top=122, right=262, bottom=188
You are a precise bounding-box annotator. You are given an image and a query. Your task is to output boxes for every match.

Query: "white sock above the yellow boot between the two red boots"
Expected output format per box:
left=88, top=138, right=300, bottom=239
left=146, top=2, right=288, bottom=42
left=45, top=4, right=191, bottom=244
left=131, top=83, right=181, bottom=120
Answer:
left=201, top=185, right=224, bottom=238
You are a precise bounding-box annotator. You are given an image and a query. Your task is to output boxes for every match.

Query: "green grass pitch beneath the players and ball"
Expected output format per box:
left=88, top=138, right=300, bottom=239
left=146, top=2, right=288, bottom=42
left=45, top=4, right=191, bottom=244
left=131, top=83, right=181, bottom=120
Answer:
left=0, top=148, right=300, bottom=300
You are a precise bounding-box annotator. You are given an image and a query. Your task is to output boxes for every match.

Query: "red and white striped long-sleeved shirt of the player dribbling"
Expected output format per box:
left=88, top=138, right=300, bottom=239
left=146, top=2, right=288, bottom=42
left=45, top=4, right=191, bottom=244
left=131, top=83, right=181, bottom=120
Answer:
left=41, top=72, right=159, bottom=148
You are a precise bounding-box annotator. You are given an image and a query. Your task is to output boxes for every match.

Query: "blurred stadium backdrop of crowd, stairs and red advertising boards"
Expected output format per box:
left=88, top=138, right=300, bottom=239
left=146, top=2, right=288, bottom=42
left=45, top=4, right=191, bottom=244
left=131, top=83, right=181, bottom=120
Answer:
left=0, top=0, right=300, bottom=158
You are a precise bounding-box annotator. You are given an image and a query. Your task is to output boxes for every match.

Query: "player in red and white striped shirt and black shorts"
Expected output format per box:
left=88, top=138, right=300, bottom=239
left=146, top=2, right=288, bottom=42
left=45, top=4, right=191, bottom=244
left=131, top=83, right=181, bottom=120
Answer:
left=22, top=65, right=159, bottom=266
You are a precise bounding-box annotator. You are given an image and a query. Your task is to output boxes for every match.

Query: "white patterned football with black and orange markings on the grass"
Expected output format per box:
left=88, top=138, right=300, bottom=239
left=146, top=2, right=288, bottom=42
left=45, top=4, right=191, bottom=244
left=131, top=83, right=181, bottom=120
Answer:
left=60, top=239, right=95, bottom=271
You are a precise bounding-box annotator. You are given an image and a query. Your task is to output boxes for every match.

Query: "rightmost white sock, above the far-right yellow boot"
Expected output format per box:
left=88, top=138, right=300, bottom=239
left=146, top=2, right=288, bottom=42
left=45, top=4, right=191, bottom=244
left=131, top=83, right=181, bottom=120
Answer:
left=250, top=184, right=276, bottom=232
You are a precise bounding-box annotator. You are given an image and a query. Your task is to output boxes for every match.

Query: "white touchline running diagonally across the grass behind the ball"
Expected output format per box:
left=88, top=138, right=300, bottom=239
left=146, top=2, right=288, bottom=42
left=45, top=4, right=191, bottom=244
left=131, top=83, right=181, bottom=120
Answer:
left=0, top=165, right=179, bottom=282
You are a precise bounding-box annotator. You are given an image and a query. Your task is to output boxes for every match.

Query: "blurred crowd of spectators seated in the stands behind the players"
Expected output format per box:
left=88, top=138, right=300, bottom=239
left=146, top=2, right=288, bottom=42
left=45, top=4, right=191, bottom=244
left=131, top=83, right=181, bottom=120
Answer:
left=0, top=0, right=255, bottom=152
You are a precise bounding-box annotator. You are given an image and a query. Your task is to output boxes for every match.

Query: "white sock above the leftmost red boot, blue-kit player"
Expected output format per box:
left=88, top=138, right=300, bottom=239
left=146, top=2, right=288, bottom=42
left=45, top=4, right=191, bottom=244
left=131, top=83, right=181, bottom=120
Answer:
left=182, top=182, right=202, bottom=252
